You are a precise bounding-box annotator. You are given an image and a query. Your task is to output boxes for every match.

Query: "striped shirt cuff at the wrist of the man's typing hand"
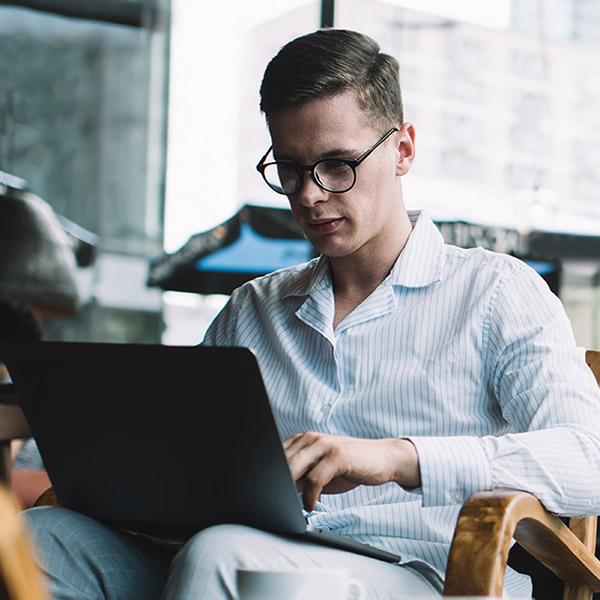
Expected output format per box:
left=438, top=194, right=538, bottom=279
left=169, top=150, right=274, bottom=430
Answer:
left=407, top=437, right=492, bottom=506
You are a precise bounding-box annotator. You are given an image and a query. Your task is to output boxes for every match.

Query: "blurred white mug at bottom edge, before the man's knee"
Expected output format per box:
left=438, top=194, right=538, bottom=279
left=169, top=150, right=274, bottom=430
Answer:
left=237, top=569, right=366, bottom=600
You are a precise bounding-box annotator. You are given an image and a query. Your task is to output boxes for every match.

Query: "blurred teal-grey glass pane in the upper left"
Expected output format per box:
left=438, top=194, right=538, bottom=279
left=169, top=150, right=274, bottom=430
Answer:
left=0, top=7, right=166, bottom=253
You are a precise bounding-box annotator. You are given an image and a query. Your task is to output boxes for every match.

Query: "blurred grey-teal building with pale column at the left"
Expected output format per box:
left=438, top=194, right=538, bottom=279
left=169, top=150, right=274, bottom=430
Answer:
left=0, top=0, right=169, bottom=341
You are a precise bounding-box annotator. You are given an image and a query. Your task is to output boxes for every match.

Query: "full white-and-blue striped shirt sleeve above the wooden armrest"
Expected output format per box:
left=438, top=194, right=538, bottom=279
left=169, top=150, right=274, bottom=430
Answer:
left=411, top=265, right=600, bottom=516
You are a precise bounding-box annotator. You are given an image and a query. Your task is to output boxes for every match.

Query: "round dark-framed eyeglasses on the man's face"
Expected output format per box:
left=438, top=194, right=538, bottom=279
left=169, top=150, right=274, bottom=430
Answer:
left=256, top=127, right=398, bottom=196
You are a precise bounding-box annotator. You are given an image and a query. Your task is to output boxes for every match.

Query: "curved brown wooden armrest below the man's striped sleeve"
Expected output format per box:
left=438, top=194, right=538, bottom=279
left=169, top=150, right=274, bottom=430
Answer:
left=444, top=491, right=600, bottom=597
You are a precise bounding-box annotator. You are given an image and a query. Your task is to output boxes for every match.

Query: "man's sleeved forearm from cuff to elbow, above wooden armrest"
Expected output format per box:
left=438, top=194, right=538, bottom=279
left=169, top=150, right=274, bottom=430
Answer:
left=412, top=427, right=600, bottom=516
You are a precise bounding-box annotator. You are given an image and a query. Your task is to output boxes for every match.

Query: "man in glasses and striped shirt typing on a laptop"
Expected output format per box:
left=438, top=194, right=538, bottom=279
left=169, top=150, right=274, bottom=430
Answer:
left=30, top=30, right=600, bottom=599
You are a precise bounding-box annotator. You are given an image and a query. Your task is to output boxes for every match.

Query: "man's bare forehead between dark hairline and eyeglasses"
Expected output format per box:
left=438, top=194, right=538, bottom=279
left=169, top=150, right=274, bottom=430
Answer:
left=269, top=92, right=377, bottom=161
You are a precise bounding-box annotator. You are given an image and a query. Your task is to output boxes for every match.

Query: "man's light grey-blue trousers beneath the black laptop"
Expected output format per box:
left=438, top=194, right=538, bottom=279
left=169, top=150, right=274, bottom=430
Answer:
left=24, top=507, right=441, bottom=600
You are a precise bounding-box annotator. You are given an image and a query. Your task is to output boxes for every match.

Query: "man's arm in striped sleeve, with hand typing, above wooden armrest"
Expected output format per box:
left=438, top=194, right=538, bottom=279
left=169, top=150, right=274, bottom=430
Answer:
left=285, top=262, right=600, bottom=514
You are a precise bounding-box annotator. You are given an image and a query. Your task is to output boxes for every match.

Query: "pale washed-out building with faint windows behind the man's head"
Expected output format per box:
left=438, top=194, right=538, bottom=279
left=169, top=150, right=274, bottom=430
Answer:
left=240, top=0, right=600, bottom=225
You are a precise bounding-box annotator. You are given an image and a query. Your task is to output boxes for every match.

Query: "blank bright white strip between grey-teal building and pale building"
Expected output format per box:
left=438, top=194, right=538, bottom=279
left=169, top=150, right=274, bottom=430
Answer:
left=165, top=0, right=316, bottom=252
